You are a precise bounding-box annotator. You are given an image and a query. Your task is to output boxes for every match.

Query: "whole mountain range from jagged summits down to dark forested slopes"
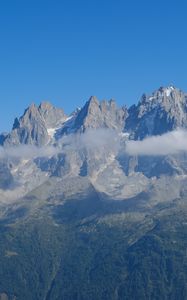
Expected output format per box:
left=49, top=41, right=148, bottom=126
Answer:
left=0, top=86, right=187, bottom=300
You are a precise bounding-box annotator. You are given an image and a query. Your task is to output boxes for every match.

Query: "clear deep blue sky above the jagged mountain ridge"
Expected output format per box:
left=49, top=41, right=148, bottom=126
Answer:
left=0, top=0, right=187, bottom=131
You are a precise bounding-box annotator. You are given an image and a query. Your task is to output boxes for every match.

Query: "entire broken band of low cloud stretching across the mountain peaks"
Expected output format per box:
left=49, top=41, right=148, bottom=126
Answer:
left=0, top=129, right=187, bottom=159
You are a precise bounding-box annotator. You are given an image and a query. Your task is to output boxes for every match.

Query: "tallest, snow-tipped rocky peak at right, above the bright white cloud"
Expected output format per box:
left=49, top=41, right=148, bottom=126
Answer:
left=125, top=86, right=187, bottom=139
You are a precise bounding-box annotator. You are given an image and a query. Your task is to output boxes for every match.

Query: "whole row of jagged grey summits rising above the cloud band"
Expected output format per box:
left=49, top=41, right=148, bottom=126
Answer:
left=0, top=85, right=187, bottom=146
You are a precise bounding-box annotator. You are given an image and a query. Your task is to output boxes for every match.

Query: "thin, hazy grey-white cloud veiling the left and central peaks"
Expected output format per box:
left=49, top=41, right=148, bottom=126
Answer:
left=0, top=129, right=119, bottom=159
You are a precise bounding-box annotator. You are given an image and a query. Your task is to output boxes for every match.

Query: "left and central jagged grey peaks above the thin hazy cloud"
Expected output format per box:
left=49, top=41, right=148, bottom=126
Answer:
left=0, top=97, right=128, bottom=146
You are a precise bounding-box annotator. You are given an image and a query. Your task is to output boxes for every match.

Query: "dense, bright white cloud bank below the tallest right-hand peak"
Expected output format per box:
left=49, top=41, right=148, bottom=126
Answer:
left=125, top=130, right=187, bottom=156
